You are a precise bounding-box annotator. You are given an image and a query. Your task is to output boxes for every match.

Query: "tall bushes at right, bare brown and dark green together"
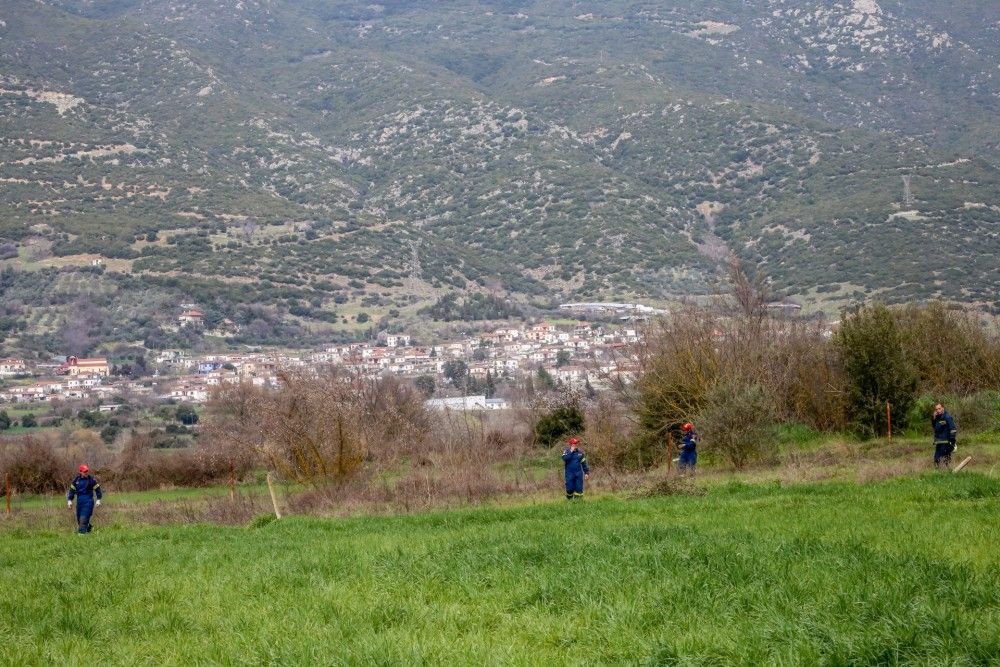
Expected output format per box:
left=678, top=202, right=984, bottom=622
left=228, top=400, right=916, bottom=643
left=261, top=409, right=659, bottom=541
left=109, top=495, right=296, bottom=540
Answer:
left=622, top=271, right=1000, bottom=465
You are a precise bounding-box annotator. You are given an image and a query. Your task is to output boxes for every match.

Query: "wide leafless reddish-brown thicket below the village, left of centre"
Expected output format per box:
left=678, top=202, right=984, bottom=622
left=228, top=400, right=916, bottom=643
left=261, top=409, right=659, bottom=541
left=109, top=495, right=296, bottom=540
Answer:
left=203, top=369, right=512, bottom=503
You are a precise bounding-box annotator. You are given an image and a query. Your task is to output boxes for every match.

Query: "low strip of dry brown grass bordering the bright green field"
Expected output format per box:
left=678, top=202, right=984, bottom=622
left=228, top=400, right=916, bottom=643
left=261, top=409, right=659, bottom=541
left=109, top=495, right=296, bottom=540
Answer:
left=0, top=434, right=1000, bottom=529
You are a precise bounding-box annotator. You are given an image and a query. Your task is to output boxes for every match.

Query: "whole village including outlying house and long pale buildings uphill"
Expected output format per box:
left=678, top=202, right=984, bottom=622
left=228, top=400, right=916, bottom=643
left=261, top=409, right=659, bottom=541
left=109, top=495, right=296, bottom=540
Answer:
left=0, top=304, right=648, bottom=412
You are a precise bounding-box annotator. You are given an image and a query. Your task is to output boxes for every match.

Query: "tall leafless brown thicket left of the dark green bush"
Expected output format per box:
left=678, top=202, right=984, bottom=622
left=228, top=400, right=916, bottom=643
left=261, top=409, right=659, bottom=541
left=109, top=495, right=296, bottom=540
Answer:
left=623, top=263, right=846, bottom=465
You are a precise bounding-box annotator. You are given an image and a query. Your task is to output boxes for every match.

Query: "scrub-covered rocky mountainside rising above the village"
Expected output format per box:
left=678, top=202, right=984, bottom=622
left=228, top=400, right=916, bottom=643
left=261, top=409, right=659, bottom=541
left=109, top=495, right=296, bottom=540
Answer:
left=0, top=0, right=1000, bottom=353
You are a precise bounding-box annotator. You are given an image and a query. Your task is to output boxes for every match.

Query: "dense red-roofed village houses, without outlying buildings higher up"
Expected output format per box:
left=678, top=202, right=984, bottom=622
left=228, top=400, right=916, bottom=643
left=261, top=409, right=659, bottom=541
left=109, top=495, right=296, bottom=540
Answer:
left=0, top=320, right=639, bottom=410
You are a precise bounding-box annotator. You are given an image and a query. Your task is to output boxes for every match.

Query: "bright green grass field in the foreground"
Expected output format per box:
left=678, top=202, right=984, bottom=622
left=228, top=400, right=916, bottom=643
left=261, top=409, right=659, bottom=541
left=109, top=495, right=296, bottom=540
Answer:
left=0, top=474, right=1000, bottom=664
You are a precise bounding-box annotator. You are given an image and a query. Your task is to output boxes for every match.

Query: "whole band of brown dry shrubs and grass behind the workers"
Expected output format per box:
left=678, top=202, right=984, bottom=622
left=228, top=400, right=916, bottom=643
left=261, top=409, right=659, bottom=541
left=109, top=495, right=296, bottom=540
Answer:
left=0, top=266, right=1000, bottom=523
